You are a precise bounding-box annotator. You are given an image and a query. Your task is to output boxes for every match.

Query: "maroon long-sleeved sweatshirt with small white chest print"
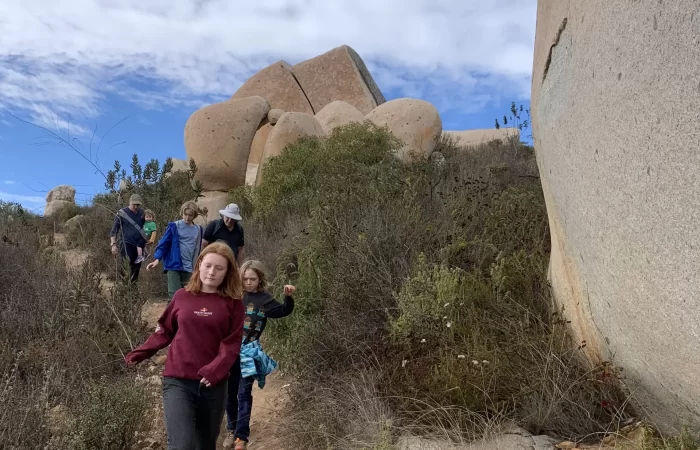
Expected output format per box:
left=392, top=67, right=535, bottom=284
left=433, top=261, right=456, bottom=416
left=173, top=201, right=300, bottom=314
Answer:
left=125, top=289, right=245, bottom=386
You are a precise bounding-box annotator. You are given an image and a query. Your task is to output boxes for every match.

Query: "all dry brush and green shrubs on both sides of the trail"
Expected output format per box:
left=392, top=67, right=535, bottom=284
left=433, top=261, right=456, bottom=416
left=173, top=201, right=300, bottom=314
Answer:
left=0, top=110, right=698, bottom=450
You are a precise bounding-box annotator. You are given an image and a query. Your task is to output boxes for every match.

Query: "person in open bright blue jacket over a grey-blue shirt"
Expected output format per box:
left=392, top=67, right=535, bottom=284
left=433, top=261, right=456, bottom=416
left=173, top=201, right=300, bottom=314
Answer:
left=146, top=201, right=203, bottom=302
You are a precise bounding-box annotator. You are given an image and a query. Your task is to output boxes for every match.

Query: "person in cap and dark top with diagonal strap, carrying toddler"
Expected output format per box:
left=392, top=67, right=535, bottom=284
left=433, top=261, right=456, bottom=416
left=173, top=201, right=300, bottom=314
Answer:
left=109, top=194, right=146, bottom=283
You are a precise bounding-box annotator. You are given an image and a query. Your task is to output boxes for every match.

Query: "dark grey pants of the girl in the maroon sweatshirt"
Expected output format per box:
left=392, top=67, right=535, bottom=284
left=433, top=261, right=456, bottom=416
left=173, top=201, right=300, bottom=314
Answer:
left=163, top=377, right=228, bottom=450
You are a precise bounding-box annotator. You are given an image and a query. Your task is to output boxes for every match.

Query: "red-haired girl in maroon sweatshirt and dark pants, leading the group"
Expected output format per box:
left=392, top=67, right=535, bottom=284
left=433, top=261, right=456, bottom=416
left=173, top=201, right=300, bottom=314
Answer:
left=125, top=242, right=245, bottom=450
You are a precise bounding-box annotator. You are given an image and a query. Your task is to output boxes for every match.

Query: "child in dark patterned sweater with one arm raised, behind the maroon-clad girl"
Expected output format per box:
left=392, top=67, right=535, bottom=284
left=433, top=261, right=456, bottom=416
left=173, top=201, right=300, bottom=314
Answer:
left=224, top=260, right=296, bottom=450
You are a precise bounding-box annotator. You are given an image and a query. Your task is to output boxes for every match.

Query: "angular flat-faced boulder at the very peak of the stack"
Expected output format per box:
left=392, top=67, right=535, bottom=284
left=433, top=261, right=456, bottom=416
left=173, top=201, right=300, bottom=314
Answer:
left=286, top=45, right=386, bottom=114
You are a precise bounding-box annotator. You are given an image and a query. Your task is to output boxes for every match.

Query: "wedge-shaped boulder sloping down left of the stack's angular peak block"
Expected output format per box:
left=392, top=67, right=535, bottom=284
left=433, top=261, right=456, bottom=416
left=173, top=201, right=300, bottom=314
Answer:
left=231, top=61, right=314, bottom=114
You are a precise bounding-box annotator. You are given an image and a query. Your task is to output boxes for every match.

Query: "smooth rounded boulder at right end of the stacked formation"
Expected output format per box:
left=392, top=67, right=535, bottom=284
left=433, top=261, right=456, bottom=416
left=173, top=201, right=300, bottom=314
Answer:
left=367, top=98, right=442, bottom=161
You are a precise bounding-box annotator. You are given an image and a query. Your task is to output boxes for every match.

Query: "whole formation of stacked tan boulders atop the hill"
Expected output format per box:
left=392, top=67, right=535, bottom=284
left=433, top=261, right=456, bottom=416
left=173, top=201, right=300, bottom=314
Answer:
left=184, top=45, right=508, bottom=222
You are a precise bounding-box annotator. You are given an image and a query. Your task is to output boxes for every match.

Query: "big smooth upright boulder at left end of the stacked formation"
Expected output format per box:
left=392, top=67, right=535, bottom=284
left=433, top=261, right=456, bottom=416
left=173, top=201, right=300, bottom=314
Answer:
left=185, top=96, right=270, bottom=191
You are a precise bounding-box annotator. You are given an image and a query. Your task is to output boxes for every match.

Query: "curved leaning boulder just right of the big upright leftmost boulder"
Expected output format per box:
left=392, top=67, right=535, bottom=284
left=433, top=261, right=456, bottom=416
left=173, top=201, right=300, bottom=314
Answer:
left=255, top=112, right=325, bottom=184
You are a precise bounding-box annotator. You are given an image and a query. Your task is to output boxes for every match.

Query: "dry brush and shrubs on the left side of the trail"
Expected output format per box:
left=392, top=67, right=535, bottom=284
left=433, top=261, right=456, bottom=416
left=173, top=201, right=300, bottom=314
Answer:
left=0, top=157, right=200, bottom=450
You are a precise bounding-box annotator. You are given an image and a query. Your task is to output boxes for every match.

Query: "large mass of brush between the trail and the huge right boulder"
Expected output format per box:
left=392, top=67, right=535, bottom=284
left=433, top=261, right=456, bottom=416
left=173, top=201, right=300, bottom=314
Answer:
left=227, top=123, right=627, bottom=448
